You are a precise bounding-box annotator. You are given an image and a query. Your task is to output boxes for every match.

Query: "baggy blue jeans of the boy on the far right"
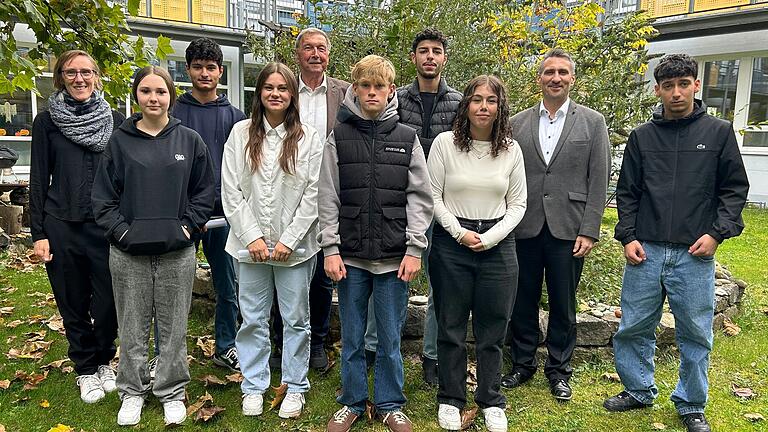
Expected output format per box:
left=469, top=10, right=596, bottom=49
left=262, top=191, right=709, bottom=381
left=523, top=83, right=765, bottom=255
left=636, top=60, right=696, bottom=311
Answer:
left=613, top=242, right=715, bottom=415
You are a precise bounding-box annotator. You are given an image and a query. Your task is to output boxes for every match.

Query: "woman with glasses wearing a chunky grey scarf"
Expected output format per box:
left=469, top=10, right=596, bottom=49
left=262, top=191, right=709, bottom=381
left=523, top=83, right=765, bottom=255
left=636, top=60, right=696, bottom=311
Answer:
left=29, top=50, right=125, bottom=403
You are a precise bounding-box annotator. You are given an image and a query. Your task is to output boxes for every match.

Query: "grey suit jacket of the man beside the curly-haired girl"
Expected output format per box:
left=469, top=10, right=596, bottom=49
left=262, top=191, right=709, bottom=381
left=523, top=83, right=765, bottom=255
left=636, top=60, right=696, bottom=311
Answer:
left=511, top=101, right=610, bottom=240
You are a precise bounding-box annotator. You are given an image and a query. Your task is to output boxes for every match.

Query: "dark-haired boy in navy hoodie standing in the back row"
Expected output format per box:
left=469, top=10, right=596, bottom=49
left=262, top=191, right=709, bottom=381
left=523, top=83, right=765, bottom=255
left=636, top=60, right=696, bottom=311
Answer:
left=172, top=38, right=245, bottom=371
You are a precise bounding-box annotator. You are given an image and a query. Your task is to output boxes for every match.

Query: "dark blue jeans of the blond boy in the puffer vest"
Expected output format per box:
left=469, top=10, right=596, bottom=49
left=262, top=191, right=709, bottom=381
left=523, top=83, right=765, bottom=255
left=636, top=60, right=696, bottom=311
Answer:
left=336, top=266, right=408, bottom=415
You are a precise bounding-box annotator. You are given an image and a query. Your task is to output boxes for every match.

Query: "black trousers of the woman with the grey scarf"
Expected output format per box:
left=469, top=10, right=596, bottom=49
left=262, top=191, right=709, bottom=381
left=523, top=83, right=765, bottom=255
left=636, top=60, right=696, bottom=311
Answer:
left=43, top=216, right=117, bottom=375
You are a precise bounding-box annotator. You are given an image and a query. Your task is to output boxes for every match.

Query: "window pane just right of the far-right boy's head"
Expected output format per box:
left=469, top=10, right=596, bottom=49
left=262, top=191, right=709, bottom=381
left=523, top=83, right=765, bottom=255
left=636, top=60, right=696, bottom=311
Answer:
left=701, top=60, right=739, bottom=121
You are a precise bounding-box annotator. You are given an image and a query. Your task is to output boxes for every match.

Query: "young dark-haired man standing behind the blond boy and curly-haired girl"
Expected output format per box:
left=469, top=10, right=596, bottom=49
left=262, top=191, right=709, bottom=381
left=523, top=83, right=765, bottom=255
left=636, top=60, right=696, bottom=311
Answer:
left=365, top=28, right=462, bottom=385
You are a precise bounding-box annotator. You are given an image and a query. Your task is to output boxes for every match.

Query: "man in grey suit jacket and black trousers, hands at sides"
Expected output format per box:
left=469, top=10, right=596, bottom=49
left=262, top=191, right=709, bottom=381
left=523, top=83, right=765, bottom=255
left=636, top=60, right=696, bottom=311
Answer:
left=501, top=49, right=610, bottom=400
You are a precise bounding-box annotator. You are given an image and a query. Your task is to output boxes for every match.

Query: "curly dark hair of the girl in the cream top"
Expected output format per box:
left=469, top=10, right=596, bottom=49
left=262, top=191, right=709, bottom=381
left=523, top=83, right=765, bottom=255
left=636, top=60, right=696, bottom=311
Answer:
left=453, top=75, right=512, bottom=157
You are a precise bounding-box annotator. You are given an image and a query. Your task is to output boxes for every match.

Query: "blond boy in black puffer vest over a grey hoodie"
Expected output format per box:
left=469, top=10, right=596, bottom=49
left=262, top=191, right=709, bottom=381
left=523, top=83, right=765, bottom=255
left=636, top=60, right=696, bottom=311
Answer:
left=319, top=55, right=432, bottom=432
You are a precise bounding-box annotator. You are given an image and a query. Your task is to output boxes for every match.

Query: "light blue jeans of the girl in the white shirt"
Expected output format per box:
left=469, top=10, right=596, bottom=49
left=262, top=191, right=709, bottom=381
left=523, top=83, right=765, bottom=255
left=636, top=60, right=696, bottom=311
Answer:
left=235, top=259, right=316, bottom=394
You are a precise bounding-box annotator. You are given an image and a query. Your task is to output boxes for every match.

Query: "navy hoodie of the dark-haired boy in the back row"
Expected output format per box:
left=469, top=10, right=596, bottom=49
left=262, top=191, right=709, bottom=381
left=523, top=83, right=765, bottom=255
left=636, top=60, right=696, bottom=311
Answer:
left=172, top=92, right=246, bottom=216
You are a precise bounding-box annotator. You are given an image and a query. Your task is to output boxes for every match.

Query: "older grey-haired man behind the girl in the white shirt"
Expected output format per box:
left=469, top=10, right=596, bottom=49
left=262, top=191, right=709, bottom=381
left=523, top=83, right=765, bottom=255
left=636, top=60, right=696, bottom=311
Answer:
left=270, top=27, right=349, bottom=370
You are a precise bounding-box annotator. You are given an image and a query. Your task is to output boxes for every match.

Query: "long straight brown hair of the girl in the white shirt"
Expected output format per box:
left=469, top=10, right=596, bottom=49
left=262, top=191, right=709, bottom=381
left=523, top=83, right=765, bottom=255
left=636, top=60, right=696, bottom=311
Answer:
left=245, top=62, right=304, bottom=174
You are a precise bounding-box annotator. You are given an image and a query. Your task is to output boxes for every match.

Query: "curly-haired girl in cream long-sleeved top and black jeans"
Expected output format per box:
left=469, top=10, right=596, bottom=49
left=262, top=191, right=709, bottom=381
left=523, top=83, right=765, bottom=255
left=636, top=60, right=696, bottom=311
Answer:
left=427, top=75, right=526, bottom=432
